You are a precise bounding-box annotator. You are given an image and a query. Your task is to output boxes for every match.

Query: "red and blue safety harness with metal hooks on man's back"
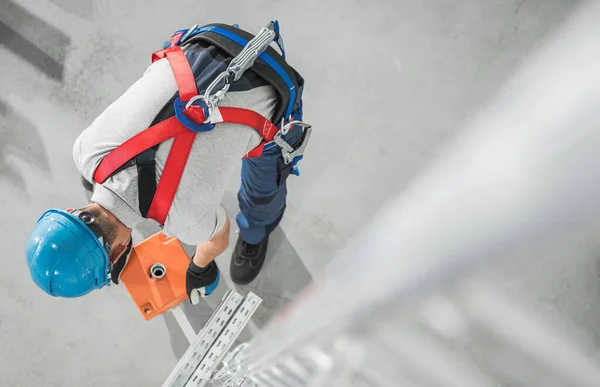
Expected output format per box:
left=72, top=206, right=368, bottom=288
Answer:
left=94, top=21, right=311, bottom=225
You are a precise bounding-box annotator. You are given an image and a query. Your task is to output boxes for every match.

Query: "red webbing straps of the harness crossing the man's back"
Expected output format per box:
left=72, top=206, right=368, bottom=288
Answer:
left=94, top=46, right=277, bottom=224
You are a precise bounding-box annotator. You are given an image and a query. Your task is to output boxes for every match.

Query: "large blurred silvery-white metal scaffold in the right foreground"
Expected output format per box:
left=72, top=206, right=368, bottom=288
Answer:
left=166, top=2, right=600, bottom=387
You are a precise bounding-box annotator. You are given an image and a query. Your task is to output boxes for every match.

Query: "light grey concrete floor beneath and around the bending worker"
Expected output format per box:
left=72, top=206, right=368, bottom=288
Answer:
left=0, top=0, right=600, bottom=387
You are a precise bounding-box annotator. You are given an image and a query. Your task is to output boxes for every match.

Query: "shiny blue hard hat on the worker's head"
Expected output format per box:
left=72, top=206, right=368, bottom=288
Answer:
left=26, top=209, right=112, bottom=298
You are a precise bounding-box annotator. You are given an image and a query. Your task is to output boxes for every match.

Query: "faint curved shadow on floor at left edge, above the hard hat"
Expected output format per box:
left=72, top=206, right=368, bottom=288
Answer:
left=0, top=98, right=50, bottom=199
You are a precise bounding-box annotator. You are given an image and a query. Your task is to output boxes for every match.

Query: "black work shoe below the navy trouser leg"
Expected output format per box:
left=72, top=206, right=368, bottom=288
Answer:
left=229, top=236, right=269, bottom=285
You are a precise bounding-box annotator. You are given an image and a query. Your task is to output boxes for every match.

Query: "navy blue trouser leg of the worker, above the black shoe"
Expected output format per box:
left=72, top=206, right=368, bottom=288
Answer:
left=236, top=127, right=302, bottom=244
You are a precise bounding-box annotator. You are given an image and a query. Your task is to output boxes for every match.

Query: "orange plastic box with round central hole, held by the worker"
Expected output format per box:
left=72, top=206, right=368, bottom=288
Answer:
left=121, top=232, right=190, bottom=320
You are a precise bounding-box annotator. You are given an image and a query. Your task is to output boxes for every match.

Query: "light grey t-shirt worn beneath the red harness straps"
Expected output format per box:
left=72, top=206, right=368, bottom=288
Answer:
left=73, top=59, right=277, bottom=245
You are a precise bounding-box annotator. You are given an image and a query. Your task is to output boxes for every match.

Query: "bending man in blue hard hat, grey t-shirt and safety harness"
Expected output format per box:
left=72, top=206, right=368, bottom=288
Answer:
left=26, top=22, right=310, bottom=304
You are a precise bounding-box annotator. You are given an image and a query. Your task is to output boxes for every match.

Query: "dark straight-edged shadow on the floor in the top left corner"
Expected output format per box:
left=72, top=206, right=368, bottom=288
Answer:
left=0, top=0, right=71, bottom=82
